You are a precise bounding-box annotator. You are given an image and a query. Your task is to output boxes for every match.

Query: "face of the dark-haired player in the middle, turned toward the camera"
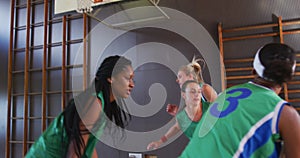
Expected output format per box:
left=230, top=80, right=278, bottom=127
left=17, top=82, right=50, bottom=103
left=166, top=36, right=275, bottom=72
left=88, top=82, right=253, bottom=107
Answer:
left=183, top=83, right=202, bottom=106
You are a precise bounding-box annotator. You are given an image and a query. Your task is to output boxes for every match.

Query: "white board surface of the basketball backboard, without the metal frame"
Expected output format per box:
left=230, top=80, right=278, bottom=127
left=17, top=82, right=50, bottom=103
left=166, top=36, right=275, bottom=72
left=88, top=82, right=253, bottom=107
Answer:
left=54, top=0, right=123, bottom=14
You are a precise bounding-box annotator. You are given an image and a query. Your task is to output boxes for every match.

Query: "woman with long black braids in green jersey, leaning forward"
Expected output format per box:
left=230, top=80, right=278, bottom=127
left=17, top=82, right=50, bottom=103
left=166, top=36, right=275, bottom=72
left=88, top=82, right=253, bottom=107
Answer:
left=26, top=55, right=134, bottom=158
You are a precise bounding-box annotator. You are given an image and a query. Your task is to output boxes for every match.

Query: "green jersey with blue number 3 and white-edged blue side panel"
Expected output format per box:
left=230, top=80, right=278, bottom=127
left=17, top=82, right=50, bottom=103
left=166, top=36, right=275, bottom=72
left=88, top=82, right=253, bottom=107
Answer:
left=180, top=82, right=286, bottom=158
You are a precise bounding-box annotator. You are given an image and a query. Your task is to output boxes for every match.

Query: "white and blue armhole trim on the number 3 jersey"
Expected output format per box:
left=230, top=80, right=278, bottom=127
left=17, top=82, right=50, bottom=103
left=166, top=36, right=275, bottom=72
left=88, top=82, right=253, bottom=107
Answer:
left=272, top=100, right=290, bottom=134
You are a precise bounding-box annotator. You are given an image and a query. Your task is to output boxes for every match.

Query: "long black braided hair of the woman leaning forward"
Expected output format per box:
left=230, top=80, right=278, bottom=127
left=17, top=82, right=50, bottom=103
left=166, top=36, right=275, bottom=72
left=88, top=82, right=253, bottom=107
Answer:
left=63, top=55, right=131, bottom=157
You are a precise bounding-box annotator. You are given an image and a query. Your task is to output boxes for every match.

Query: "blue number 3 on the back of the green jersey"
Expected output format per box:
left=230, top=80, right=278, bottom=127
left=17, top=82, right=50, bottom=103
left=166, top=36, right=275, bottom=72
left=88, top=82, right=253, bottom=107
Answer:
left=209, top=88, right=252, bottom=118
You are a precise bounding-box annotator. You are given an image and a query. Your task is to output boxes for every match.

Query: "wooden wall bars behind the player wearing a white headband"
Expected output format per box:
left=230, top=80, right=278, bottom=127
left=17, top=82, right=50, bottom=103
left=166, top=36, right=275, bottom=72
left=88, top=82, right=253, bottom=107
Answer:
left=218, top=17, right=300, bottom=111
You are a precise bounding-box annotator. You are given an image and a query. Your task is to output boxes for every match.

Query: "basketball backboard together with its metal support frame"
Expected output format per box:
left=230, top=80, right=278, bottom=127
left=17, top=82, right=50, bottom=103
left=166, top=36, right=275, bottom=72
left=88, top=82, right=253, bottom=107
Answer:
left=54, top=0, right=169, bottom=28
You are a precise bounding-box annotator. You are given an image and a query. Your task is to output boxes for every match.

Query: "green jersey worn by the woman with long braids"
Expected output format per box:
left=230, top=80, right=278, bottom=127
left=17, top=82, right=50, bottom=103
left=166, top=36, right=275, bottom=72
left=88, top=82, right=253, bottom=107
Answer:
left=25, top=92, right=105, bottom=158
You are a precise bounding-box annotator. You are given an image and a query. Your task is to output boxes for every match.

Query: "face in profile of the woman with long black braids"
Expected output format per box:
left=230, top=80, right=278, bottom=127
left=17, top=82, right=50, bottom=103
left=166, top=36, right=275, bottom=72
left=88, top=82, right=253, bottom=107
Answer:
left=111, top=66, right=134, bottom=98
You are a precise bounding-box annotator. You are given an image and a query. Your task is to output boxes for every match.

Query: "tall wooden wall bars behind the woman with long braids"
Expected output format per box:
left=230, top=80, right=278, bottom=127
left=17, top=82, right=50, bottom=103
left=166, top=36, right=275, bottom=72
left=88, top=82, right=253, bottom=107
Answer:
left=5, top=0, right=88, bottom=158
